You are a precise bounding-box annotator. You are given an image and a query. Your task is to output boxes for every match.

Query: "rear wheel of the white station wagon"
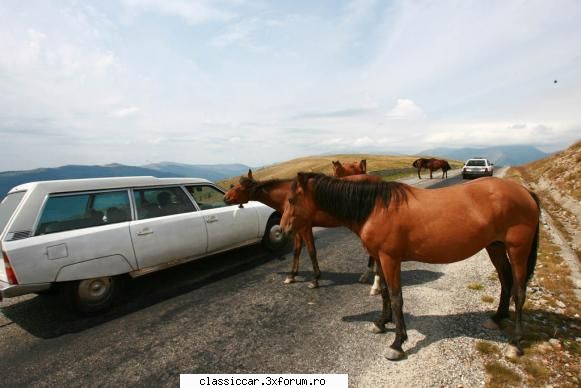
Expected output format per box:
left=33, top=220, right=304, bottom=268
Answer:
left=61, top=276, right=125, bottom=315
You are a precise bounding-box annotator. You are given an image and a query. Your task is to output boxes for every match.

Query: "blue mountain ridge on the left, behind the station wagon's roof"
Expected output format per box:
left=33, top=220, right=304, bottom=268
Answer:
left=0, top=162, right=249, bottom=199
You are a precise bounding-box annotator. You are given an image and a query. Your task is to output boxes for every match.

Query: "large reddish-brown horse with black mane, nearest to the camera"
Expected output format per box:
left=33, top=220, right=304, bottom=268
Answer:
left=281, top=173, right=540, bottom=360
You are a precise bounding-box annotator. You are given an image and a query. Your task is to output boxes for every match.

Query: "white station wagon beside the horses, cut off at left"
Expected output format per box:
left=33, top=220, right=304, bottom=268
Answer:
left=0, top=177, right=286, bottom=313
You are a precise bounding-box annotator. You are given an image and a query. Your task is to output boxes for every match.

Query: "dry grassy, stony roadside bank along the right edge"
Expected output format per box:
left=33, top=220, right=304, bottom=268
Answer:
left=476, top=156, right=581, bottom=387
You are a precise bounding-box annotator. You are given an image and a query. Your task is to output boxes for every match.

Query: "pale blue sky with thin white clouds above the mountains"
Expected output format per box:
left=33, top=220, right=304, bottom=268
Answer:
left=0, top=0, right=581, bottom=171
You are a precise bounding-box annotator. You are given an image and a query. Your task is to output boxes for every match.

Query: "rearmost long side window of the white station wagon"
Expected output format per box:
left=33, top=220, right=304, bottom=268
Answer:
left=35, top=190, right=131, bottom=235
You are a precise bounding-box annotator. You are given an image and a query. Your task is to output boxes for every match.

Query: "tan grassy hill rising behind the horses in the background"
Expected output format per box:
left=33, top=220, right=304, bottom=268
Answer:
left=219, top=154, right=462, bottom=187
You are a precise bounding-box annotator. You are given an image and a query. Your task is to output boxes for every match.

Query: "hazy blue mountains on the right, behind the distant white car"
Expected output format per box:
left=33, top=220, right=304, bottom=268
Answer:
left=418, top=145, right=550, bottom=166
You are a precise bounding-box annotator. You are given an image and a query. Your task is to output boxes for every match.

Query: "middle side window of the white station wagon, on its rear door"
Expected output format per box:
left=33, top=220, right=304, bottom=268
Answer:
left=133, top=187, right=196, bottom=220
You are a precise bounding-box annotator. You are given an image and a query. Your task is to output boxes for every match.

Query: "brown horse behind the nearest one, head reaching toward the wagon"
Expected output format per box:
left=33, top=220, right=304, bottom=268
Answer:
left=224, top=170, right=381, bottom=288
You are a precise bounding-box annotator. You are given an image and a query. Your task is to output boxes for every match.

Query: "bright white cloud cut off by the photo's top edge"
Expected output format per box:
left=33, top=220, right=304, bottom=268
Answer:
left=125, top=0, right=235, bottom=24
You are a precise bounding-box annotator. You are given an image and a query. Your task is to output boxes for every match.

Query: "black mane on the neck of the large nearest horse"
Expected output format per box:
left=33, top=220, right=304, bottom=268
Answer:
left=293, top=173, right=409, bottom=224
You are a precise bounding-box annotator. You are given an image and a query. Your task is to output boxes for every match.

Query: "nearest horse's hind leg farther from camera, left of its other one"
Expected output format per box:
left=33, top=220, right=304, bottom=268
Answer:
left=485, top=241, right=512, bottom=328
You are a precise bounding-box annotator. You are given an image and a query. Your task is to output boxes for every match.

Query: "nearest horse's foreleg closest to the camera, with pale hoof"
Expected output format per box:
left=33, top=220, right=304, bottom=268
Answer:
left=379, top=253, right=408, bottom=361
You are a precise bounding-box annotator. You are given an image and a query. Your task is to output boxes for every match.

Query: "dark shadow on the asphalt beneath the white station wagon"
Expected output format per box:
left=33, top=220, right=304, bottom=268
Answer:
left=2, top=246, right=290, bottom=339
